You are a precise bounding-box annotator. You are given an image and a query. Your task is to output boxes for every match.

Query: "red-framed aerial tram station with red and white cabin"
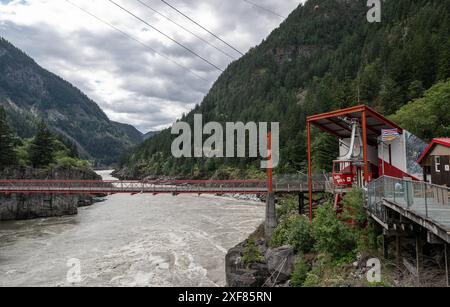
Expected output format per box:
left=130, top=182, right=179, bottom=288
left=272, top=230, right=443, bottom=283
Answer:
left=307, top=105, right=426, bottom=217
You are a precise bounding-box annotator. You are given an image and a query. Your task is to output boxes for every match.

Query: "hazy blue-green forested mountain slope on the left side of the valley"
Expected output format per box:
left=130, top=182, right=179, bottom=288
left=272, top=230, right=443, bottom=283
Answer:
left=0, top=38, right=143, bottom=165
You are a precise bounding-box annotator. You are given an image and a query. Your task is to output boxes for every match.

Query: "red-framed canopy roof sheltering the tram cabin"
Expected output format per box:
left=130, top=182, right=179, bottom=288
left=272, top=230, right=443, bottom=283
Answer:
left=308, top=105, right=403, bottom=145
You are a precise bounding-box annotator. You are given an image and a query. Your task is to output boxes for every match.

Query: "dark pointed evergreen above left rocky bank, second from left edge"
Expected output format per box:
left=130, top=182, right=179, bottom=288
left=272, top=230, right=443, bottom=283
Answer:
left=30, top=121, right=56, bottom=168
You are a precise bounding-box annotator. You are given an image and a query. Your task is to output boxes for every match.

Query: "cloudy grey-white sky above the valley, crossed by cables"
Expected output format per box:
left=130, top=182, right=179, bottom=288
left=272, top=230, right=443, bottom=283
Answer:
left=0, top=0, right=301, bottom=132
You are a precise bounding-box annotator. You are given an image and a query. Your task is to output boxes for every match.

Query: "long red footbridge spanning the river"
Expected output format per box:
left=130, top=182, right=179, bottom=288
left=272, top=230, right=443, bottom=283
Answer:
left=0, top=180, right=326, bottom=194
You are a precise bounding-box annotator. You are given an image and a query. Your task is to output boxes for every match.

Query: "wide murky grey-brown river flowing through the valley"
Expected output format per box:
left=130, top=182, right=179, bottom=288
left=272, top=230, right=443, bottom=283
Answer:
left=0, top=171, right=264, bottom=287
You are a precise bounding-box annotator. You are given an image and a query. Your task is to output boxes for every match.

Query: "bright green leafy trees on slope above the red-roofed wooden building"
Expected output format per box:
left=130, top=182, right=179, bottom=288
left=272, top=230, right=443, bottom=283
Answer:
left=392, top=80, right=450, bottom=141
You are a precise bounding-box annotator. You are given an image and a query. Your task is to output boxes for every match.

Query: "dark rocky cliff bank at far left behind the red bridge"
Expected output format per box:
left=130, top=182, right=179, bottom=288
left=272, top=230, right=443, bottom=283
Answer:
left=0, top=167, right=101, bottom=221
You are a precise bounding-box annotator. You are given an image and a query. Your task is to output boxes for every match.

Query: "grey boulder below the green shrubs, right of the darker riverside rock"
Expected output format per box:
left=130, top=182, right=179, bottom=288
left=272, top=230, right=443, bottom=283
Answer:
left=265, top=246, right=295, bottom=284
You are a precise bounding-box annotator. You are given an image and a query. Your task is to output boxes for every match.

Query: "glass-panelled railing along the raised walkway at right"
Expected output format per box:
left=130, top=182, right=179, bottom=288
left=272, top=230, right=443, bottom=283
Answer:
left=367, top=176, right=450, bottom=227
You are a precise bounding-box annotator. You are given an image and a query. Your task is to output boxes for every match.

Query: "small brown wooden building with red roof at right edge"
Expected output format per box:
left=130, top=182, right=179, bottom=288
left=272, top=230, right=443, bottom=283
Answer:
left=418, top=138, right=450, bottom=187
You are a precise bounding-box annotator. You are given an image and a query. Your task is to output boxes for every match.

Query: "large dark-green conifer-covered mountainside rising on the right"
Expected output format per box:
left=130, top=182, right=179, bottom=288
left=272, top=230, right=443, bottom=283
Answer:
left=118, top=0, right=450, bottom=178
